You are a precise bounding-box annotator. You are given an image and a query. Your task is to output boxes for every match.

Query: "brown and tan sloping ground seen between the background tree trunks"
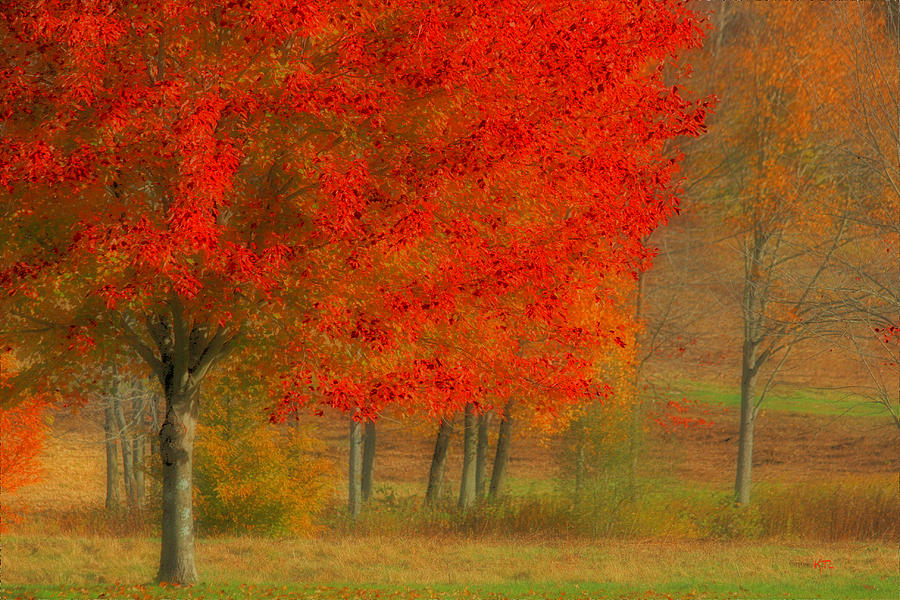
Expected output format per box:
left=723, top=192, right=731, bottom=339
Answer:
left=4, top=398, right=900, bottom=511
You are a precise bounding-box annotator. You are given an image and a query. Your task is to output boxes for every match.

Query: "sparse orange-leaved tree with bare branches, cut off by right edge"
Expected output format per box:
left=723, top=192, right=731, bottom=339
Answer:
left=820, top=0, right=900, bottom=427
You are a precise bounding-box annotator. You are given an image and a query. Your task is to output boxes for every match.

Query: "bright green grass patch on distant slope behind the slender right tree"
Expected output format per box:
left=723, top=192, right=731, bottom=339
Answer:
left=663, top=380, right=887, bottom=417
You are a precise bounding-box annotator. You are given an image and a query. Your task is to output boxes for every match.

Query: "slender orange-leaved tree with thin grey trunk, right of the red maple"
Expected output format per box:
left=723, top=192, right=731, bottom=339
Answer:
left=688, top=4, right=864, bottom=504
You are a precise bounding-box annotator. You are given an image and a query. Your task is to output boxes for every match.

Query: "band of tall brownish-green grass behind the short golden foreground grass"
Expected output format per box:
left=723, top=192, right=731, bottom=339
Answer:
left=10, top=476, right=900, bottom=542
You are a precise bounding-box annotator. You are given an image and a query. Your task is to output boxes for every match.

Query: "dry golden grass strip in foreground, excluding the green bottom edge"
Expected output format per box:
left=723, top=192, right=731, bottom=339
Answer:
left=3, top=536, right=896, bottom=586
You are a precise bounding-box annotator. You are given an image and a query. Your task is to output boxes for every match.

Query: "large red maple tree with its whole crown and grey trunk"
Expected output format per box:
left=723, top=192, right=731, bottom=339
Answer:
left=0, top=0, right=704, bottom=583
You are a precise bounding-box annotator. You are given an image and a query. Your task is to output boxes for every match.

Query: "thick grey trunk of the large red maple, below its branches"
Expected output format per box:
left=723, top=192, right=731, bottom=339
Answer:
left=156, top=390, right=198, bottom=585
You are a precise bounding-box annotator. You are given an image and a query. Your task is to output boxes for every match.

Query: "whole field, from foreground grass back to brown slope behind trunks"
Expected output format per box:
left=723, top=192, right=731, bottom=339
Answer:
left=0, top=383, right=900, bottom=600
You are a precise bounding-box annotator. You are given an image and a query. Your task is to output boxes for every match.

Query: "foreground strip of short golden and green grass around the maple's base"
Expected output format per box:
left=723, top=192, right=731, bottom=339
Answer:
left=2, top=536, right=897, bottom=599
